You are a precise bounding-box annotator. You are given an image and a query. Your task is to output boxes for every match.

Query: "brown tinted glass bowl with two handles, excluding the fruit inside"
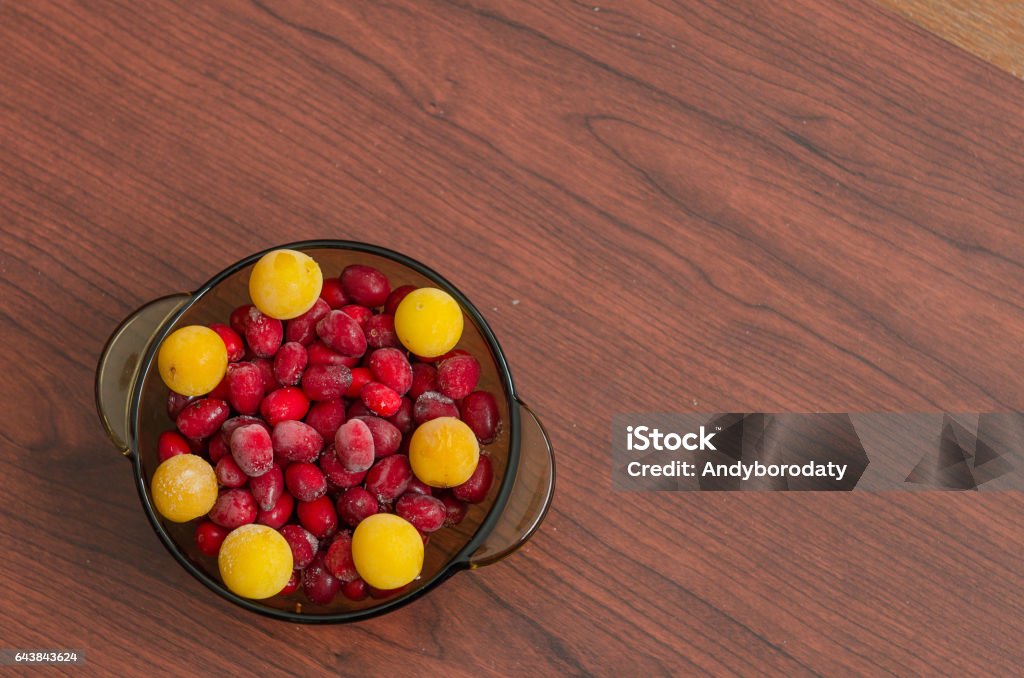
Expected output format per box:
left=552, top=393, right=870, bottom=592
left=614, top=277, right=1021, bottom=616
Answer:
left=95, top=240, right=555, bottom=624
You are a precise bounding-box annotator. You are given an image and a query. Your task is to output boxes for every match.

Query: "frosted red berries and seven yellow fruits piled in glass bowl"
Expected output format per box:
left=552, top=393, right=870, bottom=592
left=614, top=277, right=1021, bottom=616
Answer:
left=151, top=250, right=501, bottom=604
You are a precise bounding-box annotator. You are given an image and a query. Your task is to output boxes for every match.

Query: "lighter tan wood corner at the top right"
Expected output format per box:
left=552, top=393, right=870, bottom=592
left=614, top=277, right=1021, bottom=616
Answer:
left=878, top=0, right=1024, bottom=77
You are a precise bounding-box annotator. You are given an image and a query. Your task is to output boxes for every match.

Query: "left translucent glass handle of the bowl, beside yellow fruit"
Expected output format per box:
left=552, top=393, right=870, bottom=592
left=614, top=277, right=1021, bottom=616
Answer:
left=96, top=293, right=191, bottom=457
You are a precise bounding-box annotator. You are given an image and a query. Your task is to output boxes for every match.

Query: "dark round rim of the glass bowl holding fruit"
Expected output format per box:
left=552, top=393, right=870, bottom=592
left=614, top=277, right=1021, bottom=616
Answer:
left=128, top=239, right=520, bottom=624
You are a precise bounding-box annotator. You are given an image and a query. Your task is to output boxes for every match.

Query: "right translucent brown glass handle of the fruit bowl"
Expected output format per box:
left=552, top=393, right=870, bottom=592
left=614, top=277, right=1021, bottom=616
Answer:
left=469, top=400, right=555, bottom=567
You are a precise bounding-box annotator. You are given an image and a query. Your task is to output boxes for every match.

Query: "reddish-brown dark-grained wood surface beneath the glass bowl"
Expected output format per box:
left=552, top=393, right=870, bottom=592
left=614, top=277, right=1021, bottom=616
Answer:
left=0, top=0, right=1024, bottom=676
